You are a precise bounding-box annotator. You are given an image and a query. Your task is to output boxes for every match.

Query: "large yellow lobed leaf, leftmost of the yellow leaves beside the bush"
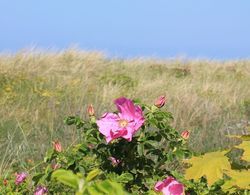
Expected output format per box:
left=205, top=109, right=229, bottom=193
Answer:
left=185, top=151, right=231, bottom=185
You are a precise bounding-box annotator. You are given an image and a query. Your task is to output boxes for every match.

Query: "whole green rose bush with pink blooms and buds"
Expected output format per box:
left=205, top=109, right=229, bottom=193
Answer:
left=0, top=96, right=246, bottom=195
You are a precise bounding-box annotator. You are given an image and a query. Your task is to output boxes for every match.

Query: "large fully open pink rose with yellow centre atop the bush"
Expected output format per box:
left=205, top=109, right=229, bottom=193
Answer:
left=96, top=97, right=144, bottom=143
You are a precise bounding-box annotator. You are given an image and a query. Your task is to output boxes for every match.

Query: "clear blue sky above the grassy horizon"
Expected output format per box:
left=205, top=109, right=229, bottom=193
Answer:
left=0, top=0, right=250, bottom=59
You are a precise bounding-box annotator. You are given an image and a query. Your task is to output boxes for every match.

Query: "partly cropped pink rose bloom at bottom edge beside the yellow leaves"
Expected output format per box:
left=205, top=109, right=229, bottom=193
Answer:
left=154, top=177, right=184, bottom=195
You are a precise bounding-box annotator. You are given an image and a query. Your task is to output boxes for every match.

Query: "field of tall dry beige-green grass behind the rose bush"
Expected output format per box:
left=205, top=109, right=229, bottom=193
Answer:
left=0, top=49, right=250, bottom=175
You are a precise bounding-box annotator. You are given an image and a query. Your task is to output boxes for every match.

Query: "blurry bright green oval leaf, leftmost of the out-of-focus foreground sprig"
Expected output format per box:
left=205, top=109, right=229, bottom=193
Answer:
left=52, top=169, right=79, bottom=190
